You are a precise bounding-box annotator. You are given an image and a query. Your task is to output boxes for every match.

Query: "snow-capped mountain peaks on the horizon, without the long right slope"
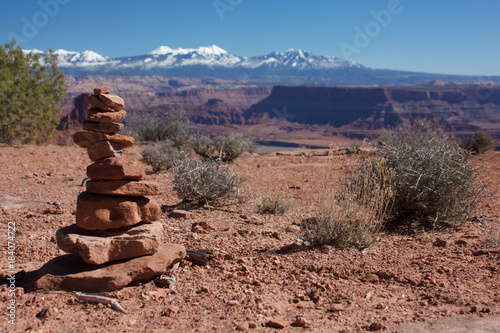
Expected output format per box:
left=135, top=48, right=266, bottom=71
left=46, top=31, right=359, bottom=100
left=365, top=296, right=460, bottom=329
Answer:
left=25, top=45, right=363, bottom=74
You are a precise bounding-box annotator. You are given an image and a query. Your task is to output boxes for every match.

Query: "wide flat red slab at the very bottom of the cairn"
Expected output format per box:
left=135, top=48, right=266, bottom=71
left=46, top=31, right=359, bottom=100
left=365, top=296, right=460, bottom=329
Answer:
left=19, top=244, right=186, bottom=292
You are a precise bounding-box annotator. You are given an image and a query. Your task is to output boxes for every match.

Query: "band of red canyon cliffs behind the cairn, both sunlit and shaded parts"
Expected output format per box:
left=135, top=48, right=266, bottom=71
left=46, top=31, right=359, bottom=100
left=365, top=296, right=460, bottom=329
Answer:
left=55, top=82, right=500, bottom=144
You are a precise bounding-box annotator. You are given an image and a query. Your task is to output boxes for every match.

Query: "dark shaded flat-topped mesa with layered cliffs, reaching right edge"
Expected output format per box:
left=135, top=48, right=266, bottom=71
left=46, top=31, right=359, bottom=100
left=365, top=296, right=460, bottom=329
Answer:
left=244, top=85, right=500, bottom=137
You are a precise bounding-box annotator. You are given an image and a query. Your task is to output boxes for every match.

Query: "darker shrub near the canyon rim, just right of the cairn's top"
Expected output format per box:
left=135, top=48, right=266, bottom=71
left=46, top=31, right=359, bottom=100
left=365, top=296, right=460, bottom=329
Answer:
left=128, top=110, right=192, bottom=148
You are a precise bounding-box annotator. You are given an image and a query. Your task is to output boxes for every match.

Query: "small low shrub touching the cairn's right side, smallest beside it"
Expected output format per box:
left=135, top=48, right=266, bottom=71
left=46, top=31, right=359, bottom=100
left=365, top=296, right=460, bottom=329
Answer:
left=142, top=142, right=187, bottom=172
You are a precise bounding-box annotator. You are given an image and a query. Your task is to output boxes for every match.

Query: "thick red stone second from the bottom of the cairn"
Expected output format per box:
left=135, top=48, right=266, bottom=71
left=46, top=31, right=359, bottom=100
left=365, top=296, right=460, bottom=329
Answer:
left=56, top=222, right=163, bottom=265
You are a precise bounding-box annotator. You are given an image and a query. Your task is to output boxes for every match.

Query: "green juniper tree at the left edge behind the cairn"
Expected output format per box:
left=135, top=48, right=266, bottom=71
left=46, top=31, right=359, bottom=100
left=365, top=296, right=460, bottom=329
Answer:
left=0, top=40, right=66, bottom=144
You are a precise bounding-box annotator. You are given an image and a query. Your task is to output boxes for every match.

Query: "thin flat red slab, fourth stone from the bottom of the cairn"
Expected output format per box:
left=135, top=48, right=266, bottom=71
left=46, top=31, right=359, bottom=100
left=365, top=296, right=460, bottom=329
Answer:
left=87, top=180, right=160, bottom=196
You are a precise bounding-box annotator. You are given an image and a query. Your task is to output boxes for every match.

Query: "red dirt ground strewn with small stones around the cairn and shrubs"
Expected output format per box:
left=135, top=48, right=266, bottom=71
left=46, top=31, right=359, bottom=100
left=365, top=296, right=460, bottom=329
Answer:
left=0, top=145, right=500, bottom=332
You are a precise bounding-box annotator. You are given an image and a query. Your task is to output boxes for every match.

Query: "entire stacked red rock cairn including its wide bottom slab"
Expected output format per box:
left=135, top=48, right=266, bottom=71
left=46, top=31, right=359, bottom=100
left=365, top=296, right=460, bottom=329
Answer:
left=20, top=87, right=186, bottom=291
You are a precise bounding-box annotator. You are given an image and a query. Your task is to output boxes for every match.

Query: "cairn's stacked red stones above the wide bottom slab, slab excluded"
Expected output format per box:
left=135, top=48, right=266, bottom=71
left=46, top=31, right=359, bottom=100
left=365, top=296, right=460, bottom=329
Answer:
left=56, top=87, right=163, bottom=265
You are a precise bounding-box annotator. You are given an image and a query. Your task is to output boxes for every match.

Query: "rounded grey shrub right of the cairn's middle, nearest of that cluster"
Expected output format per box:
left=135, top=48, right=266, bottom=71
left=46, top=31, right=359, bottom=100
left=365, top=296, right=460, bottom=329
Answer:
left=172, top=157, right=245, bottom=206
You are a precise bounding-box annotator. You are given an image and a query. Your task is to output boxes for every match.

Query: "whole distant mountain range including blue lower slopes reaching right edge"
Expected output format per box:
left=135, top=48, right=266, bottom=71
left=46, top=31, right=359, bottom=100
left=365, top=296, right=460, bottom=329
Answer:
left=25, top=45, right=500, bottom=86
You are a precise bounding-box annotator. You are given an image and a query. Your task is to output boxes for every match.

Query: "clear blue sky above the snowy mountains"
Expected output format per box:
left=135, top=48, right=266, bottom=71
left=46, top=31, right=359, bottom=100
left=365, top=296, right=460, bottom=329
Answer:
left=0, top=0, right=500, bottom=75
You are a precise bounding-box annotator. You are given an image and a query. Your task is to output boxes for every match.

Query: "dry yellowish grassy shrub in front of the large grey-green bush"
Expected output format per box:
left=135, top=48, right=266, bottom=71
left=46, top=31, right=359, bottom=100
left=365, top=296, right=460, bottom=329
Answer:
left=302, top=147, right=393, bottom=249
